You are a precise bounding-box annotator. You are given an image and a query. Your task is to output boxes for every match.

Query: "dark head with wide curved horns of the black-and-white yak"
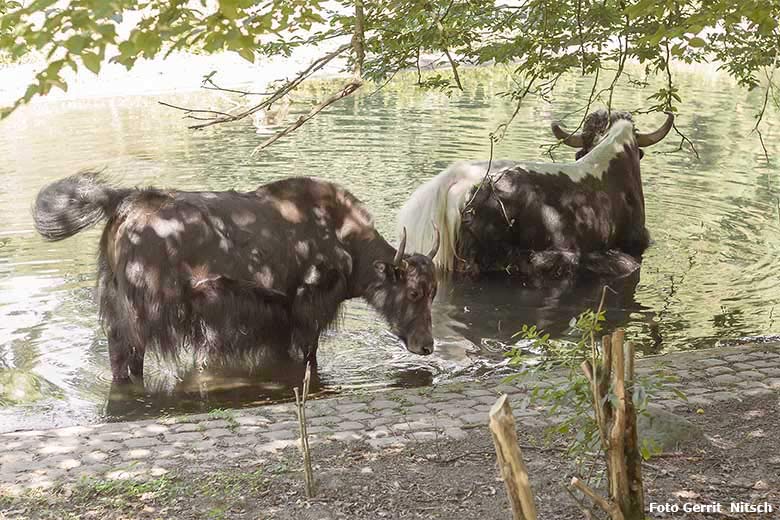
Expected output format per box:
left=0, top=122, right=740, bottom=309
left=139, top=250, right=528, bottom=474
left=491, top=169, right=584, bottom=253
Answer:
left=552, top=109, right=674, bottom=159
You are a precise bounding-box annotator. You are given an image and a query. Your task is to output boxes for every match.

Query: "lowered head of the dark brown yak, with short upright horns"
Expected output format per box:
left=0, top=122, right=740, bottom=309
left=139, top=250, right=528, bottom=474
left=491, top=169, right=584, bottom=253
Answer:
left=370, top=229, right=439, bottom=356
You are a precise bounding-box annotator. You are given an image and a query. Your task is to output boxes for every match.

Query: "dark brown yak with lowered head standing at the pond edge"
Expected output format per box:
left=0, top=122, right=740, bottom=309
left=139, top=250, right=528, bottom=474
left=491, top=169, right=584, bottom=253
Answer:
left=33, top=173, right=438, bottom=381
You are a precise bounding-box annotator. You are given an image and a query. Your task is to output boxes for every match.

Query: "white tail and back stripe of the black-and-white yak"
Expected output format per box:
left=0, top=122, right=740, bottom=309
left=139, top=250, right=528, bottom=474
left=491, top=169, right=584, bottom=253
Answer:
left=397, top=119, right=634, bottom=271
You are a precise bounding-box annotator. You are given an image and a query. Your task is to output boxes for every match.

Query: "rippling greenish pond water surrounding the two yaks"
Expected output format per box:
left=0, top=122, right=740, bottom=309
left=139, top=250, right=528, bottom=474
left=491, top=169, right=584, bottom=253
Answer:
left=0, top=66, right=780, bottom=431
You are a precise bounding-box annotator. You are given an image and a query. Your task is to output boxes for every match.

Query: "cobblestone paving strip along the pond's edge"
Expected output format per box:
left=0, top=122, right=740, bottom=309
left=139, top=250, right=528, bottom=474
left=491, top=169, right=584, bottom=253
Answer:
left=0, top=344, right=780, bottom=495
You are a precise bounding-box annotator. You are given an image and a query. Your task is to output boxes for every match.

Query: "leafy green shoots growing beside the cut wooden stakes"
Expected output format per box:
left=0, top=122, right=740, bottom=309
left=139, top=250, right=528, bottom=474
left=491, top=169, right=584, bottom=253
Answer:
left=507, top=309, right=676, bottom=472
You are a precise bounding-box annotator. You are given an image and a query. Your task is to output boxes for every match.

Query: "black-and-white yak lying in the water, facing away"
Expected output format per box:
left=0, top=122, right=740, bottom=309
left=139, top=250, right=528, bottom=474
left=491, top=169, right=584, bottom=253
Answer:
left=398, top=110, right=674, bottom=283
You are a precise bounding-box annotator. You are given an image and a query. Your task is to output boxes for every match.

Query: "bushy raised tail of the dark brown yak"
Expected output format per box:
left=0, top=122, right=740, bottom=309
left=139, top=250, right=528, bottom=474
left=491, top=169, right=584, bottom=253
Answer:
left=33, top=172, right=132, bottom=241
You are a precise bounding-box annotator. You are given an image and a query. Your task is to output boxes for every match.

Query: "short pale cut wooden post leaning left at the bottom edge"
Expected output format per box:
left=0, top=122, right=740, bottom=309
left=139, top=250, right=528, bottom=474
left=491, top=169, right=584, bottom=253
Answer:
left=490, top=394, right=536, bottom=520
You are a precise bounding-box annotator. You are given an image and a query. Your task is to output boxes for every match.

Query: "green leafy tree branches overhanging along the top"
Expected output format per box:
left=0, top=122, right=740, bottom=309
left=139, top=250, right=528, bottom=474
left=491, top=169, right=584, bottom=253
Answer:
left=0, top=0, right=780, bottom=130
